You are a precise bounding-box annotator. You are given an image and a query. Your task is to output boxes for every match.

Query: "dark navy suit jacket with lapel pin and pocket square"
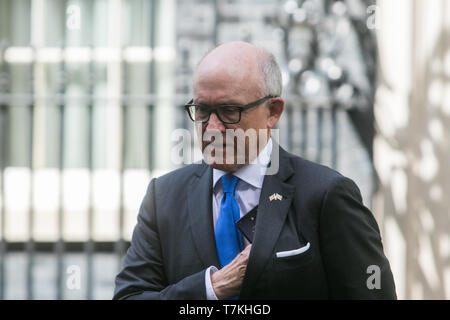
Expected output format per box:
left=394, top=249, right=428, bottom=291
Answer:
left=114, top=146, right=396, bottom=299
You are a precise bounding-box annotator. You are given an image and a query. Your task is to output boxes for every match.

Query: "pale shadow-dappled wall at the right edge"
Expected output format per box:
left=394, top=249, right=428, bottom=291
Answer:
left=374, top=0, right=450, bottom=299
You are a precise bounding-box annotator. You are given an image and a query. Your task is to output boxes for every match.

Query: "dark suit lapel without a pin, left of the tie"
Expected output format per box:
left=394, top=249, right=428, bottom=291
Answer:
left=186, top=163, right=220, bottom=268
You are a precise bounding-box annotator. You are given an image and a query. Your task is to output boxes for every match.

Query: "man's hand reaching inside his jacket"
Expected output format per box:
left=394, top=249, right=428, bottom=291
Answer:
left=211, top=244, right=252, bottom=300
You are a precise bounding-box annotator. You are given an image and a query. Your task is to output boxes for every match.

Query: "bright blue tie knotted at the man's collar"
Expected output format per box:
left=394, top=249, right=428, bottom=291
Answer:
left=216, top=174, right=244, bottom=267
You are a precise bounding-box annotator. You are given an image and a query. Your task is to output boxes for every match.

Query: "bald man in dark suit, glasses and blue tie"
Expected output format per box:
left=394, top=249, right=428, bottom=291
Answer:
left=114, top=42, right=396, bottom=299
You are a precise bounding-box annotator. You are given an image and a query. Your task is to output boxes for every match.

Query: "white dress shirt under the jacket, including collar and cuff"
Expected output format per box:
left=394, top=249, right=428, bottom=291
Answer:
left=205, top=138, right=272, bottom=300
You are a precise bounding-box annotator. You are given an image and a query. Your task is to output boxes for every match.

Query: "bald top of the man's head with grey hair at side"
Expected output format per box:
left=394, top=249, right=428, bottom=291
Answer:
left=194, top=41, right=281, bottom=98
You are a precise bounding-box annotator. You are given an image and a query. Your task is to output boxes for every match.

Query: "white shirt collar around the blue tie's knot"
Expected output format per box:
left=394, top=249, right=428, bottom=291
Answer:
left=213, top=138, right=272, bottom=189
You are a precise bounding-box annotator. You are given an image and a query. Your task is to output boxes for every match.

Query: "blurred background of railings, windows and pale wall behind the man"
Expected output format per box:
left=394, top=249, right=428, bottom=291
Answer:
left=0, top=0, right=450, bottom=299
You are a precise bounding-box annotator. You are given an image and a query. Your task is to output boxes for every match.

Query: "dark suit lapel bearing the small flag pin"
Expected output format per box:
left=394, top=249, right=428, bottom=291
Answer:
left=239, top=148, right=295, bottom=299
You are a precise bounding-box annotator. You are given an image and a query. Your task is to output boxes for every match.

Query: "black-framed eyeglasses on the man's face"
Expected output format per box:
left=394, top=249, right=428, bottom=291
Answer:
left=184, top=95, right=276, bottom=124
